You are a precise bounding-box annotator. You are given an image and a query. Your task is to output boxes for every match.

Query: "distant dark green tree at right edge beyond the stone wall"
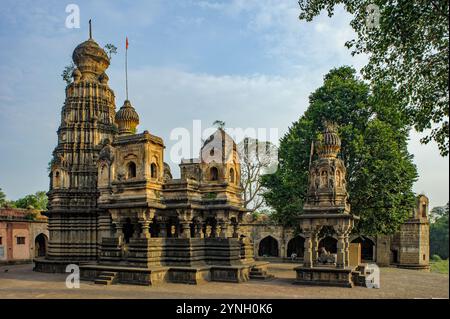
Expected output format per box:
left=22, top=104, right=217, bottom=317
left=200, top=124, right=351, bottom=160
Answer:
left=430, top=203, right=449, bottom=259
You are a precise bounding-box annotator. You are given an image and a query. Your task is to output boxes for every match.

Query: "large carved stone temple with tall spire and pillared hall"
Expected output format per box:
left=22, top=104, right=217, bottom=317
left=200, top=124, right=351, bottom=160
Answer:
left=35, top=34, right=270, bottom=285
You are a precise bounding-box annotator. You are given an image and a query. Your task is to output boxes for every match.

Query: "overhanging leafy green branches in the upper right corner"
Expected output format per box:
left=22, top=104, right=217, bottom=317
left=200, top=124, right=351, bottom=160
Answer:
left=299, top=0, right=449, bottom=156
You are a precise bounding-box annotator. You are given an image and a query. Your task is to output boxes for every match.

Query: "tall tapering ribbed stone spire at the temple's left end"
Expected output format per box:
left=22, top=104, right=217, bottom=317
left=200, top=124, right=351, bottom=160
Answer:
left=44, top=29, right=116, bottom=262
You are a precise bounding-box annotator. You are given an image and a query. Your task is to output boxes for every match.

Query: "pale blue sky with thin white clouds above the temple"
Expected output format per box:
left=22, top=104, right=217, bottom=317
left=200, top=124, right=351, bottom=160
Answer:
left=0, top=0, right=449, bottom=206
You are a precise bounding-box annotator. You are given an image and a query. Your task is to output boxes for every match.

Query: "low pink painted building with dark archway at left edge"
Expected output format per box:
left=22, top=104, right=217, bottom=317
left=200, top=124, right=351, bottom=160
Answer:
left=0, top=208, right=48, bottom=265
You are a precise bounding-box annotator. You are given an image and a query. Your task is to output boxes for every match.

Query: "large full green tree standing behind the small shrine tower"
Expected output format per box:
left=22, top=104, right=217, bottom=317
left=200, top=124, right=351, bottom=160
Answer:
left=262, top=67, right=417, bottom=235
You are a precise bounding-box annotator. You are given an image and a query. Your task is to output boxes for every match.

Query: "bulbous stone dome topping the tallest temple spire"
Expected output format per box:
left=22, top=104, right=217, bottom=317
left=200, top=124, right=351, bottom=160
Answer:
left=72, top=39, right=109, bottom=80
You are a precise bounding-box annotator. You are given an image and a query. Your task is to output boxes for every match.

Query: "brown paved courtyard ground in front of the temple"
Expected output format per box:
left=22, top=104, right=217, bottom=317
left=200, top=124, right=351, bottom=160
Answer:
left=0, top=263, right=449, bottom=299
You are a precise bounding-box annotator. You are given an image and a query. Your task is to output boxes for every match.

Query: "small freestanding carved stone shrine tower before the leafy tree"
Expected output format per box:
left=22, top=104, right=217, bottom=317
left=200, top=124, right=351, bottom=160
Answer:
left=295, top=122, right=357, bottom=287
